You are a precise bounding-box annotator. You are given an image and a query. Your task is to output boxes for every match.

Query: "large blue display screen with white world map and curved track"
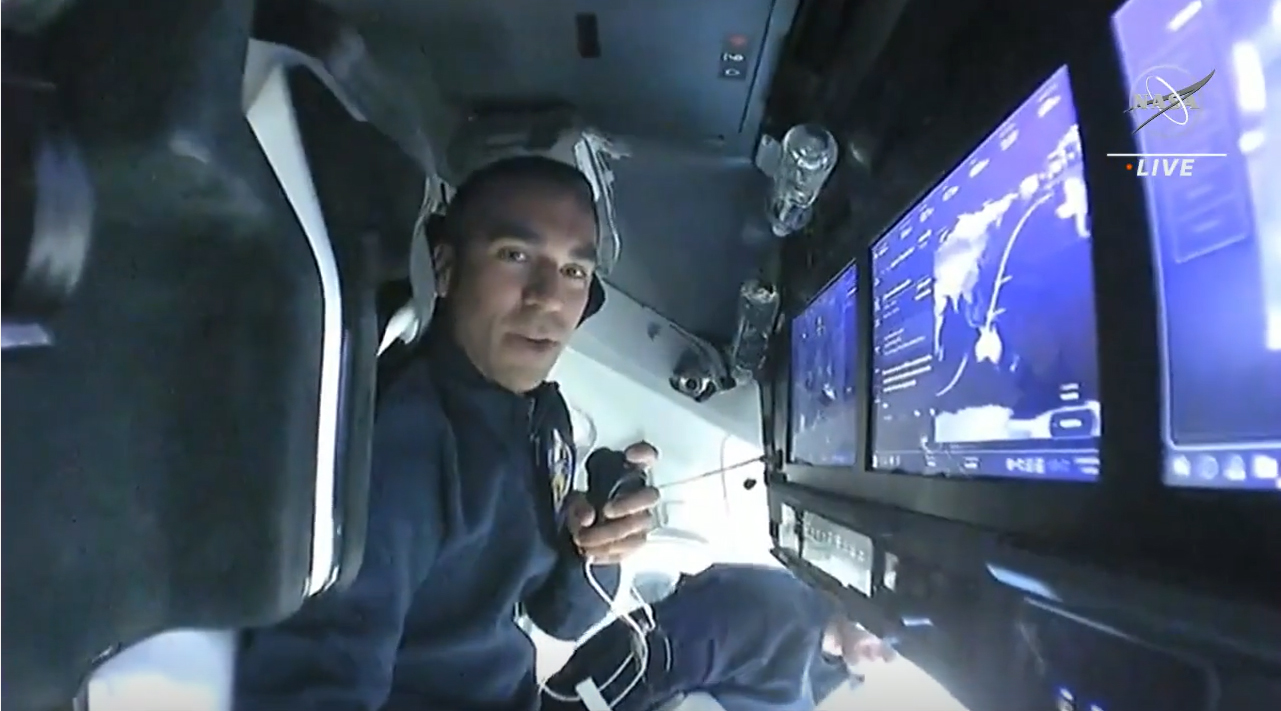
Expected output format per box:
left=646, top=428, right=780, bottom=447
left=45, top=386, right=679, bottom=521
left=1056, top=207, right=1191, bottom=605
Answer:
left=872, top=68, right=1102, bottom=479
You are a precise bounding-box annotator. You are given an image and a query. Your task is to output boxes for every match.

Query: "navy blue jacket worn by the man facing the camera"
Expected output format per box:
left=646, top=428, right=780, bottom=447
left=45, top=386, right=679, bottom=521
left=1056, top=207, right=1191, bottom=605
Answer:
left=234, top=329, right=619, bottom=711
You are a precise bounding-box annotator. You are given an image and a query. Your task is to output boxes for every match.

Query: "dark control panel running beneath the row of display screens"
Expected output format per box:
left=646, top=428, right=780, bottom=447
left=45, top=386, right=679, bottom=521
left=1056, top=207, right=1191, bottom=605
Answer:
left=771, top=488, right=1281, bottom=711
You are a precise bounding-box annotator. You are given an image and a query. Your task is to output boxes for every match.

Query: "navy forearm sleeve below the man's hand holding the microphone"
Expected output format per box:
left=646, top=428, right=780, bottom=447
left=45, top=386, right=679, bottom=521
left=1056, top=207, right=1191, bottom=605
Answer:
left=525, top=537, right=620, bottom=641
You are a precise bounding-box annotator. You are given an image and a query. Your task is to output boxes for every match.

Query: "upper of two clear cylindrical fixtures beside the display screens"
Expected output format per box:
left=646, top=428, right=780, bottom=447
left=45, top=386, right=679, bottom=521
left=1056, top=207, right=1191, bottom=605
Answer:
left=769, top=123, right=839, bottom=237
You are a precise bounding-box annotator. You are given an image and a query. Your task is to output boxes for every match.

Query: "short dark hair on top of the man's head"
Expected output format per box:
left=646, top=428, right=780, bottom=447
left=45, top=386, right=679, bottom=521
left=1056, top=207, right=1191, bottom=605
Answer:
left=433, top=155, right=600, bottom=246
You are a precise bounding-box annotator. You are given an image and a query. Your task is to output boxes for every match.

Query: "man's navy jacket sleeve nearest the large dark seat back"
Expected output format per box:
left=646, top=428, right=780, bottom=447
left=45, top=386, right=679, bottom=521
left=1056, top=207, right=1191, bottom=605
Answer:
left=234, top=373, right=447, bottom=711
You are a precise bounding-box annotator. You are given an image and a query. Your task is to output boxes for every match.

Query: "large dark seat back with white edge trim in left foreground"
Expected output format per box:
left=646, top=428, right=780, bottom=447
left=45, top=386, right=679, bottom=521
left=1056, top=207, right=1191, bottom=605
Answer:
left=3, top=0, right=384, bottom=710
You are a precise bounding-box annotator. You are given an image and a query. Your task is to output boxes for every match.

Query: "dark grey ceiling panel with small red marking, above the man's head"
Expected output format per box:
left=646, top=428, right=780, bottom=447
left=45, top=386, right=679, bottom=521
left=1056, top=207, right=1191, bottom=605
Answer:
left=329, top=0, right=797, bottom=155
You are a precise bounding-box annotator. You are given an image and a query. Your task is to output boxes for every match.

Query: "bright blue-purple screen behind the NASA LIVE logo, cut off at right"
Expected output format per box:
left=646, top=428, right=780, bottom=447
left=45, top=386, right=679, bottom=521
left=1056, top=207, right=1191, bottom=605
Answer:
left=1113, top=0, right=1281, bottom=491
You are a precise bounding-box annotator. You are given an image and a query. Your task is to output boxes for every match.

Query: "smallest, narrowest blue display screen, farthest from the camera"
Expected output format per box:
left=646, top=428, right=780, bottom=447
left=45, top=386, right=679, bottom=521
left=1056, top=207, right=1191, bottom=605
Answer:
left=792, top=264, right=858, bottom=466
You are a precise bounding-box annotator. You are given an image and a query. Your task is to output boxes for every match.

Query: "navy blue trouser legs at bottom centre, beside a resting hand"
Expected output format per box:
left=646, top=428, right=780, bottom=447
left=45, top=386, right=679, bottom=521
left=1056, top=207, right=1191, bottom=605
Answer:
left=543, top=564, right=851, bottom=711
